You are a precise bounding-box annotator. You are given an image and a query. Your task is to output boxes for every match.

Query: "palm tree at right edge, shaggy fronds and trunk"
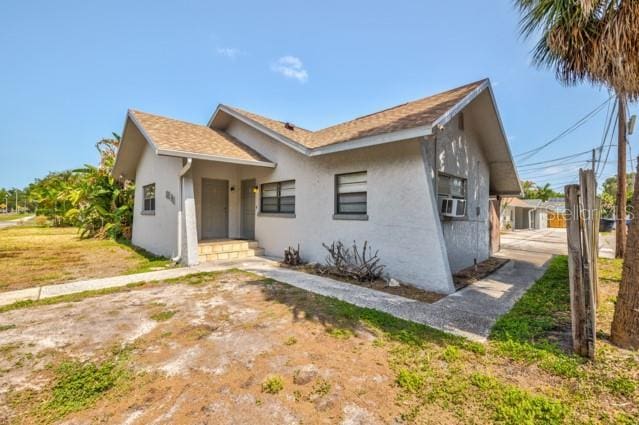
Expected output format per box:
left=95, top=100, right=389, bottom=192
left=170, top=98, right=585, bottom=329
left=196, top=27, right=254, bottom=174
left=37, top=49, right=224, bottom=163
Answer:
left=515, top=0, right=639, bottom=348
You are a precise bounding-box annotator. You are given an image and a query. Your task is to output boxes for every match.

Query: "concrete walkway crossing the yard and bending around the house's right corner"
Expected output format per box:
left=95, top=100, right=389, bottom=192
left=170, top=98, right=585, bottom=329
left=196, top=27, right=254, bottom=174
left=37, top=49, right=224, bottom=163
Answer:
left=0, top=250, right=551, bottom=341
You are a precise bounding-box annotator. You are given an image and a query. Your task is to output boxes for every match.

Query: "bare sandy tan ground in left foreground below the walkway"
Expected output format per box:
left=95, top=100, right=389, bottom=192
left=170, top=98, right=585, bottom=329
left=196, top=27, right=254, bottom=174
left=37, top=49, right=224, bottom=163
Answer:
left=0, top=273, right=399, bottom=424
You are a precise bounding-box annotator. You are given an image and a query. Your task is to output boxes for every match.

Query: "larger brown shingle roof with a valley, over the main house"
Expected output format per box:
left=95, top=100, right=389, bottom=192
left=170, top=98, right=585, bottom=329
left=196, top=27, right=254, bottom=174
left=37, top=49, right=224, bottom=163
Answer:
left=229, top=80, right=486, bottom=149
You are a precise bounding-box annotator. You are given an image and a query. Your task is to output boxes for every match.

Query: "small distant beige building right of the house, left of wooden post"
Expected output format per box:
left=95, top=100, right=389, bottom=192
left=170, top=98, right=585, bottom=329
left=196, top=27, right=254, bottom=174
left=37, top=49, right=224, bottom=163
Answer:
left=501, top=198, right=548, bottom=230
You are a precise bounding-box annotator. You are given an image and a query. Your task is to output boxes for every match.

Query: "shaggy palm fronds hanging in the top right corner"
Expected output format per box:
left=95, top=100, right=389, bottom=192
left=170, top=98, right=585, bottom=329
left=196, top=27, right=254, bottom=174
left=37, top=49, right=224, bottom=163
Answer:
left=515, top=0, right=639, bottom=99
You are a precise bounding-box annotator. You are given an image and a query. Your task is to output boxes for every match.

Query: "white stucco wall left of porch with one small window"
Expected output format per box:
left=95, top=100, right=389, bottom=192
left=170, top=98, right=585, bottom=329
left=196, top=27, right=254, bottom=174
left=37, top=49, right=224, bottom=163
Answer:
left=132, top=145, right=182, bottom=257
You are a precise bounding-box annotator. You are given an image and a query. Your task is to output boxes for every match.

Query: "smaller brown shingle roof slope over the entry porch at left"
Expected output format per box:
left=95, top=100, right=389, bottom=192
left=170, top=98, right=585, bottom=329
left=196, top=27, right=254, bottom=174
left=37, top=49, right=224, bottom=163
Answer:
left=130, top=110, right=268, bottom=162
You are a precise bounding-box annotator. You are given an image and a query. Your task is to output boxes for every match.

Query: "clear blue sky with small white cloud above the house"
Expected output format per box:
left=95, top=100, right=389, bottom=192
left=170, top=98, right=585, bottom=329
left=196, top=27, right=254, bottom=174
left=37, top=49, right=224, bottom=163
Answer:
left=0, top=0, right=639, bottom=187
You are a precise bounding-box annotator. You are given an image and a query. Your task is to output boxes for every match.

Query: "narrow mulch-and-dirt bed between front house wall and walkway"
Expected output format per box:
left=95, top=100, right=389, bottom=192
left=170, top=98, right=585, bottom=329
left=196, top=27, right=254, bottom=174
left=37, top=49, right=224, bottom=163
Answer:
left=280, top=263, right=446, bottom=304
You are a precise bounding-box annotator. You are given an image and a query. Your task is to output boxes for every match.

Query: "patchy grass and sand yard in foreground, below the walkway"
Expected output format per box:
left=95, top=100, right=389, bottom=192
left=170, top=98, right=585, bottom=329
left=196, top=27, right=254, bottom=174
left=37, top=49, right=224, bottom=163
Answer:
left=0, top=257, right=639, bottom=425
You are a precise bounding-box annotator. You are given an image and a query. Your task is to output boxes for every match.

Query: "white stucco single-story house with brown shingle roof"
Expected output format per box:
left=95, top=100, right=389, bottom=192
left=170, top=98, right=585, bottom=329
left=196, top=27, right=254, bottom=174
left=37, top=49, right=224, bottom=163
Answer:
left=113, top=79, right=521, bottom=293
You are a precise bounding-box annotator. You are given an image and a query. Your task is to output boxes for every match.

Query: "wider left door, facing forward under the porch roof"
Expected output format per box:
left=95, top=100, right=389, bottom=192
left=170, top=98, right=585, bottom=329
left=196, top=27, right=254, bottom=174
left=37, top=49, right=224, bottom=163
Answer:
left=202, top=179, right=229, bottom=239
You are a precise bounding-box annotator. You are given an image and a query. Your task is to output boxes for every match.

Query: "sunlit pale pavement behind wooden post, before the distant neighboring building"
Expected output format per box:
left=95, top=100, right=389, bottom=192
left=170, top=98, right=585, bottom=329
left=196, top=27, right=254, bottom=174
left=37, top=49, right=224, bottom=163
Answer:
left=501, top=229, right=615, bottom=258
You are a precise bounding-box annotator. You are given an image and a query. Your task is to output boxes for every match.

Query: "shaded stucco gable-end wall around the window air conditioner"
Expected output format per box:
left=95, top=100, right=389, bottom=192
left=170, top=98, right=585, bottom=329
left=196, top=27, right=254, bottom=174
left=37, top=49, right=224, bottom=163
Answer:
left=424, top=115, right=490, bottom=272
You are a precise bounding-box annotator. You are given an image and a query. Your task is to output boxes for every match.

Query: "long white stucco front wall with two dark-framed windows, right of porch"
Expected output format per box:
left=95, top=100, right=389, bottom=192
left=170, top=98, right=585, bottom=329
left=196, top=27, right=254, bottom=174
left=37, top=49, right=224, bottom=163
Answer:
left=220, top=121, right=456, bottom=293
